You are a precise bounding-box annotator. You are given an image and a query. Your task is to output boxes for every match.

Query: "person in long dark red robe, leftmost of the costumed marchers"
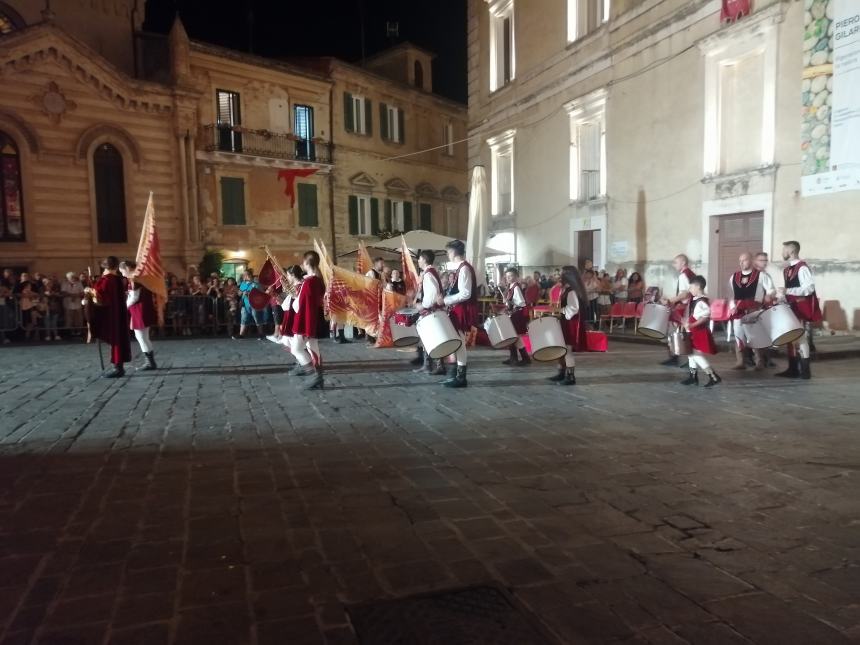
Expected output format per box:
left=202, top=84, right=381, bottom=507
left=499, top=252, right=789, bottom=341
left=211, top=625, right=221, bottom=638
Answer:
left=88, top=256, right=131, bottom=378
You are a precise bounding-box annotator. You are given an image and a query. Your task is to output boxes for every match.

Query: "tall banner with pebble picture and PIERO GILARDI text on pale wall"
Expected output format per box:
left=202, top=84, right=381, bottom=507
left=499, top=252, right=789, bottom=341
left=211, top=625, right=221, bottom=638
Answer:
left=801, top=0, right=860, bottom=196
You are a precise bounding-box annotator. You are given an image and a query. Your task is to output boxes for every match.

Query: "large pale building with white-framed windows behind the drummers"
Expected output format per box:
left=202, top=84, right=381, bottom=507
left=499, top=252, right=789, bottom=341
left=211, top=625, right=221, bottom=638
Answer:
left=468, top=0, right=860, bottom=328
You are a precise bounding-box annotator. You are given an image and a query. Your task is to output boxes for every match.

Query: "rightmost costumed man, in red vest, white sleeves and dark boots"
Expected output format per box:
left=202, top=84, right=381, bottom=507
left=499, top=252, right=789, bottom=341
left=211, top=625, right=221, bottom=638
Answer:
left=777, top=241, right=823, bottom=379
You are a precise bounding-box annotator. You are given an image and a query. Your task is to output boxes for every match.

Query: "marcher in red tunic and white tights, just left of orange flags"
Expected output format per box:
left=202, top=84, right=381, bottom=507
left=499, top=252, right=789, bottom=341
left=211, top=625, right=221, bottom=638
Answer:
left=291, top=251, right=328, bottom=390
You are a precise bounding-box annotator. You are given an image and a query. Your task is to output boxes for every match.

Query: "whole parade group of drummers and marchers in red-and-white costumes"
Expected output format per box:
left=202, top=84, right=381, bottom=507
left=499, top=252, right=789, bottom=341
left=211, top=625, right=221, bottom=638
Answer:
left=86, top=234, right=822, bottom=390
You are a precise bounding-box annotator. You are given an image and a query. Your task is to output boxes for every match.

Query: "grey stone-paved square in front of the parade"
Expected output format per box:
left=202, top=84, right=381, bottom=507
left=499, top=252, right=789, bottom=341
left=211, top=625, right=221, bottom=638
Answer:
left=0, top=340, right=860, bottom=645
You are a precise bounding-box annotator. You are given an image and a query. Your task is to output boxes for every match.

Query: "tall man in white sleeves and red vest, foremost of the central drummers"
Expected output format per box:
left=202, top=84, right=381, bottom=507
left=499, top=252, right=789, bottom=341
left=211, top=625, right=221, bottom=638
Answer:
left=436, top=240, right=478, bottom=388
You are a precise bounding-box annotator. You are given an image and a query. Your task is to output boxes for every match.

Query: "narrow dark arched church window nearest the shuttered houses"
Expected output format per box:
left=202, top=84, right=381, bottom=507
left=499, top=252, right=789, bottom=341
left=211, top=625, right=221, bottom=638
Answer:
left=93, top=143, right=128, bottom=244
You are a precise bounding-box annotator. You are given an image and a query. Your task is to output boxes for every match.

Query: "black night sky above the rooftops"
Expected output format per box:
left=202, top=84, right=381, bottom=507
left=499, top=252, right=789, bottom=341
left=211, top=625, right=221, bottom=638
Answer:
left=144, top=0, right=466, bottom=103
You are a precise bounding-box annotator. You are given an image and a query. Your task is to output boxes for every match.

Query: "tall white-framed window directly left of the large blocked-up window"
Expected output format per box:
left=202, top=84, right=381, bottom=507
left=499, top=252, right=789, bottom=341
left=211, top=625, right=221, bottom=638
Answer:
left=566, top=90, right=606, bottom=201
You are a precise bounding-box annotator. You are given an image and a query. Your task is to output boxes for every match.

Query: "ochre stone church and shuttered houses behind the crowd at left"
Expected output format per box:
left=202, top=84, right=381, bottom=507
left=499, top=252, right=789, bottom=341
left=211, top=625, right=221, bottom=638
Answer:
left=0, top=0, right=467, bottom=274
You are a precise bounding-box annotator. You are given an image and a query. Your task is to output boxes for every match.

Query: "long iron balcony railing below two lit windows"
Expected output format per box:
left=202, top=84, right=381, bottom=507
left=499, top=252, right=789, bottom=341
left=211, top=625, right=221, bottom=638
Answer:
left=203, top=123, right=331, bottom=164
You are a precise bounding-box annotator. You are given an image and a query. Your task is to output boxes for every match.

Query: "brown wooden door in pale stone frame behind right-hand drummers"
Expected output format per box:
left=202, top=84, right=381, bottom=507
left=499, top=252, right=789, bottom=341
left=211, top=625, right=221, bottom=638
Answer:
left=708, top=211, right=764, bottom=299
